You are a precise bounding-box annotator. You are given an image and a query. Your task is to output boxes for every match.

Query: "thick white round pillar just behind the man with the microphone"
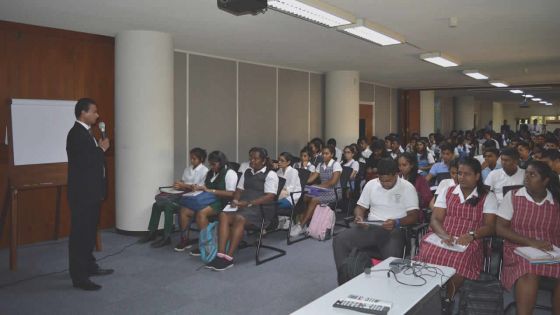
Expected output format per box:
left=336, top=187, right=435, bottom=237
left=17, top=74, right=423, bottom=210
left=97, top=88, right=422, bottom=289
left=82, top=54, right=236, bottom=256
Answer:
left=115, top=31, right=173, bottom=232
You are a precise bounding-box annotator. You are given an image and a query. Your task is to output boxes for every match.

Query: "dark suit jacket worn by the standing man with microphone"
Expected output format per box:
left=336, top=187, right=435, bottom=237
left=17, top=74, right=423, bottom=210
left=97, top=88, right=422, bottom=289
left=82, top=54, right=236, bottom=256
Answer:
left=66, top=122, right=106, bottom=203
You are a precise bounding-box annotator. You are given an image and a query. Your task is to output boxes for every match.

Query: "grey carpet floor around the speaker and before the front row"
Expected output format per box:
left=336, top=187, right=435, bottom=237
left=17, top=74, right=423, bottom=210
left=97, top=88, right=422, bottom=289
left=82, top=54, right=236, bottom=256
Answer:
left=0, top=230, right=550, bottom=315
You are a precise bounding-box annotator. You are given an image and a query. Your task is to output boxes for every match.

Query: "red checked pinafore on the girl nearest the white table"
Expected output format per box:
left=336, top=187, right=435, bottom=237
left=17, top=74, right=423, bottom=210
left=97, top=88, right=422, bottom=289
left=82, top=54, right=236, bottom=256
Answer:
left=414, top=187, right=488, bottom=280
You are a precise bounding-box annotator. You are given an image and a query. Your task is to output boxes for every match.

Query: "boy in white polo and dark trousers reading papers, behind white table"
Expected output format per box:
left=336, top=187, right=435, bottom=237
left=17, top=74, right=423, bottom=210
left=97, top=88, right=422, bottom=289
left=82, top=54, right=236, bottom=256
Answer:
left=333, top=158, right=418, bottom=284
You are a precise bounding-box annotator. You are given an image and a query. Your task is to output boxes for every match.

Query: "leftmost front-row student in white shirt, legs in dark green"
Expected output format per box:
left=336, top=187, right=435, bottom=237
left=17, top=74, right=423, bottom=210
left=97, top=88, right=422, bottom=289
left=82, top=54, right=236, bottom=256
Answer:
left=138, top=148, right=208, bottom=248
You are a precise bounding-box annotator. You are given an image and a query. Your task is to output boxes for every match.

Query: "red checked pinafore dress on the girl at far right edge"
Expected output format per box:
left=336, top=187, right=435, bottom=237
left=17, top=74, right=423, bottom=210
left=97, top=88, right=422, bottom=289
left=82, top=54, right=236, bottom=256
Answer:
left=501, top=190, right=560, bottom=290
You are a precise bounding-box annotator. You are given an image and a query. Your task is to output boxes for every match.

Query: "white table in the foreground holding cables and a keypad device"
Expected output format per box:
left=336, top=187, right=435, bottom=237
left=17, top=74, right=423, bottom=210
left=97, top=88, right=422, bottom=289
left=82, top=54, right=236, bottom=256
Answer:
left=292, top=257, right=455, bottom=315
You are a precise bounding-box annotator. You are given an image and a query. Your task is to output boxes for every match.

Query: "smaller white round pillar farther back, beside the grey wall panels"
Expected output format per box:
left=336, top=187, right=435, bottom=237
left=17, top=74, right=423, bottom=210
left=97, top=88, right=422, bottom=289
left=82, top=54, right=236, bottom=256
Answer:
left=325, top=71, right=360, bottom=146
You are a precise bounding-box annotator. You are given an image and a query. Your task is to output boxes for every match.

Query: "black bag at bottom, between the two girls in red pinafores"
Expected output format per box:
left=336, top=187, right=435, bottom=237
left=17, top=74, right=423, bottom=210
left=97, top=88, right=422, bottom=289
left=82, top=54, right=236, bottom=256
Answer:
left=459, top=273, right=504, bottom=315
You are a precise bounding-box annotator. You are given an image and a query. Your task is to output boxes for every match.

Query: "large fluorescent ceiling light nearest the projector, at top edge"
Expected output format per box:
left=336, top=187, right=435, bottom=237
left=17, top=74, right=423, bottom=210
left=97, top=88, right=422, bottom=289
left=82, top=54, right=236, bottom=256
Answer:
left=268, top=0, right=352, bottom=27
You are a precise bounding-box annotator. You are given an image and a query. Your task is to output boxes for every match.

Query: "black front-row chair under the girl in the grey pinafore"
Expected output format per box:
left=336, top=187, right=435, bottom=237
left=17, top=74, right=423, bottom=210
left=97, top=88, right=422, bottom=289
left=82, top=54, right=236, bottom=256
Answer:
left=239, top=178, right=286, bottom=266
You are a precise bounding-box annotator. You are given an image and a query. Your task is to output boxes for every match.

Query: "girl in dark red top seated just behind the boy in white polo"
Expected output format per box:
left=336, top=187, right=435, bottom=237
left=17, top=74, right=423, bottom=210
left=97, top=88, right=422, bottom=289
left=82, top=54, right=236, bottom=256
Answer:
left=398, top=152, right=432, bottom=209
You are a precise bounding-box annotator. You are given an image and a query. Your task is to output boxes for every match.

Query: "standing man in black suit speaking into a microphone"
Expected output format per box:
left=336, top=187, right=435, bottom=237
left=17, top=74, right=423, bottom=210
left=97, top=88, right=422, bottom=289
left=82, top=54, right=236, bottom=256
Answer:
left=66, top=98, right=113, bottom=291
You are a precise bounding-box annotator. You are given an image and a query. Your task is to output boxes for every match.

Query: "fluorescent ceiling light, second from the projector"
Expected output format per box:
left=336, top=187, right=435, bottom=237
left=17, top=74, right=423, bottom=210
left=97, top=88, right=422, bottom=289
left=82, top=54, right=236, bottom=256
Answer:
left=338, top=19, right=404, bottom=46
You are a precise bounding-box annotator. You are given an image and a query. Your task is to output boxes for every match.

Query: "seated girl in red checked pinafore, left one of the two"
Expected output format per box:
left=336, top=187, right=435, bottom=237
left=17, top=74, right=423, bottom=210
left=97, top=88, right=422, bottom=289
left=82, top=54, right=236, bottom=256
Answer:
left=415, top=158, right=498, bottom=309
